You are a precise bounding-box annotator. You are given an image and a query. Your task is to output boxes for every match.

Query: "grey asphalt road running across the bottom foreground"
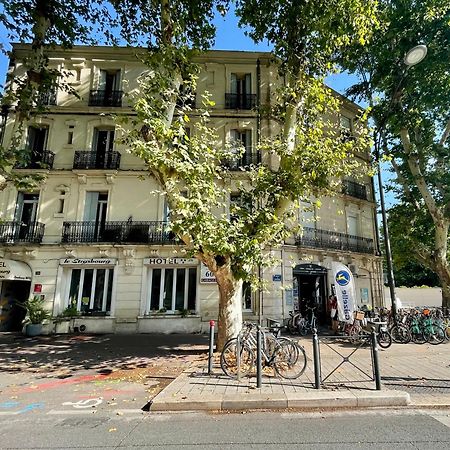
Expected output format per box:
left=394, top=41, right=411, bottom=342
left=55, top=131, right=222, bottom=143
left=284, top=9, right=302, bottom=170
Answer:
left=0, top=409, right=450, bottom=450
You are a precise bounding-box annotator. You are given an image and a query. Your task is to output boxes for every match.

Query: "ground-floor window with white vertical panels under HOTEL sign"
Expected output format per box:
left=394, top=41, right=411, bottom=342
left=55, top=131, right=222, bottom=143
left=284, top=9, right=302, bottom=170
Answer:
left=147, top=267, right=197, bottom=312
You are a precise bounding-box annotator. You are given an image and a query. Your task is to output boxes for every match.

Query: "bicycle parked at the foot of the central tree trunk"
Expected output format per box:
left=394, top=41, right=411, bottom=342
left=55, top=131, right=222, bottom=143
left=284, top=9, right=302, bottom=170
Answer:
left=220, top=323, right=307, bottom=379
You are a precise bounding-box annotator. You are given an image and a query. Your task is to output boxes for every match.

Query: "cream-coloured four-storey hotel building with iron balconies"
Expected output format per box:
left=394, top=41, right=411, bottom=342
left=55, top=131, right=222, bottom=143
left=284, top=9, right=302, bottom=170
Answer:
left=0, top=45, right=383, bottom=333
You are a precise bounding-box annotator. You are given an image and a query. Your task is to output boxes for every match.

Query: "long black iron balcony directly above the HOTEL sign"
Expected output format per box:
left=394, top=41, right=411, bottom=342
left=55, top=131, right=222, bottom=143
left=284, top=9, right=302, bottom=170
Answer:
left=62, top=221, right=180, bottom=245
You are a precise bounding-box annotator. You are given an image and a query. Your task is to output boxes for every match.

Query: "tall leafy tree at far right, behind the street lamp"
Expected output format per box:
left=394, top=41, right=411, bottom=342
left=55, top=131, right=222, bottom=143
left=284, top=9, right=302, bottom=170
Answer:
left=343, top=0, right=450, bottom=307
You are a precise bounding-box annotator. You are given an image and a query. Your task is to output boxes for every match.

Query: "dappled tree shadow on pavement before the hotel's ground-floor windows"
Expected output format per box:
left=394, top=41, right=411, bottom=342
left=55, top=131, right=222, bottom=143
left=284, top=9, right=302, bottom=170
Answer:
left=0, top=333, right=208, bottom=378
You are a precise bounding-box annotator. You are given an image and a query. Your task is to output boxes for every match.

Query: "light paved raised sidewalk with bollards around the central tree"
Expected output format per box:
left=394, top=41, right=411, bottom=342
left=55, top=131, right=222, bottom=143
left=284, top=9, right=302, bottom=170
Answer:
left=150, top=338, right=450, bottom=411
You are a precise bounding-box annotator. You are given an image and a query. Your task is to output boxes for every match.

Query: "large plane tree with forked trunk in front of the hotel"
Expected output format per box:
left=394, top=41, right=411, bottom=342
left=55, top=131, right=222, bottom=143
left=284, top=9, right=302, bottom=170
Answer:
left=123, top=0, right=375, bottom=348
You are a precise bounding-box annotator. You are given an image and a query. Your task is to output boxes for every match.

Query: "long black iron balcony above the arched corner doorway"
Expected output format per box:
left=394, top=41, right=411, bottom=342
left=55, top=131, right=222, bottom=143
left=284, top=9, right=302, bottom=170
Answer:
left=295, top=227, right=375, bottom=254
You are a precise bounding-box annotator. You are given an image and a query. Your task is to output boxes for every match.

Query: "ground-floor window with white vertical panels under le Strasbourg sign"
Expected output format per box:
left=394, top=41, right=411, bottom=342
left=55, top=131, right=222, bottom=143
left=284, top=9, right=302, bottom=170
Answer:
left=67, top=268, right=114, bottom=314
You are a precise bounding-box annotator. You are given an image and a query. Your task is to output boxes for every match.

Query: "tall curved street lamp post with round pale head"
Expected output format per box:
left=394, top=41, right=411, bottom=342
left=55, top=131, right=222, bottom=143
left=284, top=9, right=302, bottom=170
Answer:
left=375, top=45, right=427, bottom=324
